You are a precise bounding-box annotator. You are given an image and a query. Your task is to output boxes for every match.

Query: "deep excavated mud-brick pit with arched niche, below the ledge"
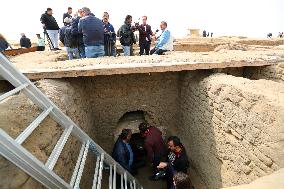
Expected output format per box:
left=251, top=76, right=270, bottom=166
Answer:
left=0, top=65, right=284, bottom=189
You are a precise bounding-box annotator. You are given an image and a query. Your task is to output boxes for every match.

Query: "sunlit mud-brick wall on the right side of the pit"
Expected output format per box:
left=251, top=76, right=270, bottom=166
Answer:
left=178, top=73, right=284, bottom=188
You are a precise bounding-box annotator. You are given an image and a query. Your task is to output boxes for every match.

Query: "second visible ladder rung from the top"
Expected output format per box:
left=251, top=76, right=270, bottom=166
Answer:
left=16, top=107, right=52, bottom=144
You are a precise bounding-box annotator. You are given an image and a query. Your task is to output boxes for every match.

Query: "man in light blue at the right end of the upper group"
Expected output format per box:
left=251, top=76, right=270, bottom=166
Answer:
left=150, top=21, right=173, bottom=55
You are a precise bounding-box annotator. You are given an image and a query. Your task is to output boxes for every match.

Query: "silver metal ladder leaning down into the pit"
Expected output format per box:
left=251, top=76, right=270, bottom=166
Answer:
left=0, top=53, right=143, bottom=189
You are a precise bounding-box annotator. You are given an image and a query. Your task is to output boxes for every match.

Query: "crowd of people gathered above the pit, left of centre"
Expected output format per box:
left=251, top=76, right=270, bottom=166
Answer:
left=0, top=7, right=173, bottom=60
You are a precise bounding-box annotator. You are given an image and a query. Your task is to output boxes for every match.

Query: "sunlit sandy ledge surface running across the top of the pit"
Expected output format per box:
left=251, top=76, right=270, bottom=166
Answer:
left=10, top=47, right=284, bottom=71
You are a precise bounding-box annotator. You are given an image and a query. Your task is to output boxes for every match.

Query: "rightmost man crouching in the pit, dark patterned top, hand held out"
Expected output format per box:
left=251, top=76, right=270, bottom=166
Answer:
left=157, top=136, right=189, bottom=189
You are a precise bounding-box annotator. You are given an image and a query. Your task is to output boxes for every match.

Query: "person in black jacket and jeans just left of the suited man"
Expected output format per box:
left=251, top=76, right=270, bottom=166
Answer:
left=118, top=15, right=136, bottom=56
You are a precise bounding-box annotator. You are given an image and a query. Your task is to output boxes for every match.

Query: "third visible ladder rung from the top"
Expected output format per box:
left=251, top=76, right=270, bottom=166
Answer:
left=45, top=125, right=73, bottom=170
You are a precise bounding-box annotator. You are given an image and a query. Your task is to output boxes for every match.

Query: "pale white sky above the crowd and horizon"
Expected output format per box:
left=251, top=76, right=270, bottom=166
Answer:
left=0, top=0, right=284, bottom=40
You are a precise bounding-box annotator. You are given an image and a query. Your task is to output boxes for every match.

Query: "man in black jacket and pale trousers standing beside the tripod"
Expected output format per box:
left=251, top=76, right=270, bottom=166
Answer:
left=40, top=8, right=60, bottom=50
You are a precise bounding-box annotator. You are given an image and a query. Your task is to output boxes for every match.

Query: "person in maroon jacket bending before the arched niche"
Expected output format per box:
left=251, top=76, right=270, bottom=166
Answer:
left=139, top=123, right=165, bottom=180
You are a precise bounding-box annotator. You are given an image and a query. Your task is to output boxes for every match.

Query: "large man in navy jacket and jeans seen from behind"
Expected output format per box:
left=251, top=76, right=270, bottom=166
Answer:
left=78, top=7, right=105, bottom=58
